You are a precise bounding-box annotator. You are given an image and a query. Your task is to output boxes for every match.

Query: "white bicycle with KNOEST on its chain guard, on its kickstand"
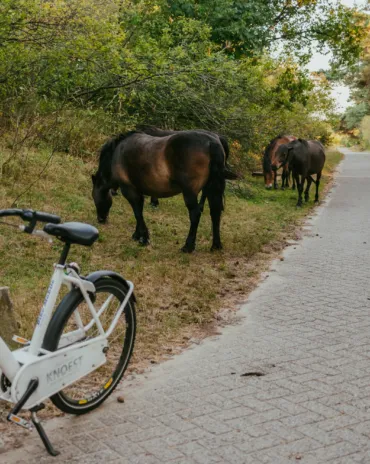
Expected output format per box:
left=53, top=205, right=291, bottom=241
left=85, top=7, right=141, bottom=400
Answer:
left=0, top=209, right=136, bottom=456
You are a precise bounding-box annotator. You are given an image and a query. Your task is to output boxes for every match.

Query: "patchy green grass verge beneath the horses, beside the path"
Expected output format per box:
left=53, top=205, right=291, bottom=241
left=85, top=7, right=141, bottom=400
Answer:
left=0, top=147, right=341, bottom=366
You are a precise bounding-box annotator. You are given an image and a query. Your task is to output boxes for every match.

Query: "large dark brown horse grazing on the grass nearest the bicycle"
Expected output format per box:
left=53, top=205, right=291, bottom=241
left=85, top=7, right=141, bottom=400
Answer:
left=92, top=131, right=225, bottom=253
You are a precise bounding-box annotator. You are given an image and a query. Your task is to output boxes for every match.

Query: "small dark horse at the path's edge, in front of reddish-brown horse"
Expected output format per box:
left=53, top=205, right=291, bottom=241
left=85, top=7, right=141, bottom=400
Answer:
left=272, top=139, right=325, bottom=206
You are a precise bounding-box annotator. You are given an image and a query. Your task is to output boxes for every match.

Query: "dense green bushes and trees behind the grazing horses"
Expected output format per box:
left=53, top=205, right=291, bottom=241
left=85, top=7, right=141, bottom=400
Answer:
left=0, top=0, right=362, bottom=165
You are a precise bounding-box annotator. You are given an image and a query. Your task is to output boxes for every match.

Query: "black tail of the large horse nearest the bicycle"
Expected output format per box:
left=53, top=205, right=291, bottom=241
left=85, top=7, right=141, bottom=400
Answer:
left=206, top=141, right=226, bottom=210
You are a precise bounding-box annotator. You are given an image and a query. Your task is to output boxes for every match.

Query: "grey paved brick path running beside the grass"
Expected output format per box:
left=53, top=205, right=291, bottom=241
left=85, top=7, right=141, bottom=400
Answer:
left=0, top=153, right=370, bottom=464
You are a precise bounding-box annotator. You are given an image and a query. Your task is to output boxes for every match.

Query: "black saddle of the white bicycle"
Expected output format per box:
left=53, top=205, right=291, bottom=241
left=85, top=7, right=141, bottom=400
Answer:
left=44, top=222, right=99, bottom=246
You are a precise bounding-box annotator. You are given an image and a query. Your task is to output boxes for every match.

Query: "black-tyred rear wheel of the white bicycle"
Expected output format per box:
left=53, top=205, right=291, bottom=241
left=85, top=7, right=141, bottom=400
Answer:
left=43, top=277, right=136, bottom=414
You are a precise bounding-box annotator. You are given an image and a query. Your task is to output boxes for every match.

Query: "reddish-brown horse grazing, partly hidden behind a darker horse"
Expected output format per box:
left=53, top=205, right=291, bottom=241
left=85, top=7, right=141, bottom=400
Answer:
left=263, top=135, right=296, bottom=190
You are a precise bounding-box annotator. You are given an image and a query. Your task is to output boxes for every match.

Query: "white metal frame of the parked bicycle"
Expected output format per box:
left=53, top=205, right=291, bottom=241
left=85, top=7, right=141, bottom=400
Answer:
left=0, top=264, right=134, bottom=407
